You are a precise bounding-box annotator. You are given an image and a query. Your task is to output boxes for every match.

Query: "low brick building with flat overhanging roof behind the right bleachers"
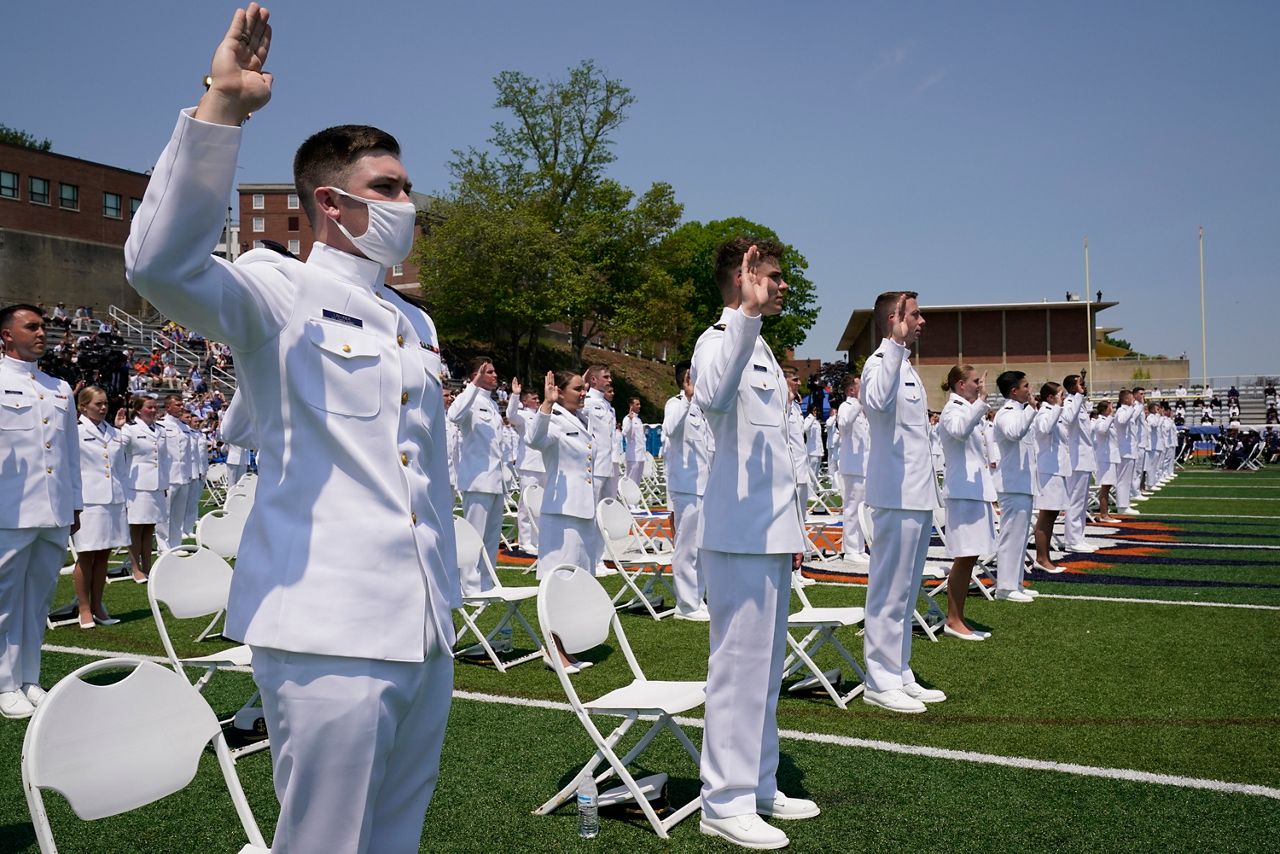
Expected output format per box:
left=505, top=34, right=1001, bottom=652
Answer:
left=837, top=300, right=1190, bottom=410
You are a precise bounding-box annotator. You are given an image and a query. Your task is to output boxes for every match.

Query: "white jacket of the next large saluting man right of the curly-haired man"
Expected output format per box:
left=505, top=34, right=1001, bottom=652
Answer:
left=861, top=338, right=941, bottom=511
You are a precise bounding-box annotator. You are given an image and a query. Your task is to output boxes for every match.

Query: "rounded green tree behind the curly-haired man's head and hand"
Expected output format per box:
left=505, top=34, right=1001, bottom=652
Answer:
left=662, top=216, right=818, bottom=357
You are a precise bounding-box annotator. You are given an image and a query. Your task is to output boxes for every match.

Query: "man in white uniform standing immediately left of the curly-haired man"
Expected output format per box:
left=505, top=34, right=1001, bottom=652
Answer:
left=662, top=361, right=716, bottom=622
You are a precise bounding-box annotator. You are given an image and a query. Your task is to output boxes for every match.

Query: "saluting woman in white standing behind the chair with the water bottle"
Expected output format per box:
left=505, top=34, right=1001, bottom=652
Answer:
left=525, top=371, right=593, bottom=673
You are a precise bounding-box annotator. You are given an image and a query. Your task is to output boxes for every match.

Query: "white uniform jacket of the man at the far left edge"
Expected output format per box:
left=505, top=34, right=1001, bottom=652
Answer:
left=0, top=357, right=84, bottom=529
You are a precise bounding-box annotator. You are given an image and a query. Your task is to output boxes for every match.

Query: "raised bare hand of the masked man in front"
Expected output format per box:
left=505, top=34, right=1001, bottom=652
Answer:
left=196, top=3, right=271, bottom=124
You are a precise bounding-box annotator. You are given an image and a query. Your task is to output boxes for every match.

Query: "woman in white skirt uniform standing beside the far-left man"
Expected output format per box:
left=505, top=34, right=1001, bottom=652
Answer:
left=72, top=385, right=129, bottom=629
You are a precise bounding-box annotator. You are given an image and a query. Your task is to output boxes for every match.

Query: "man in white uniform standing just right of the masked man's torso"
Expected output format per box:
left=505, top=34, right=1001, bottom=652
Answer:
left=449, top=356, right=506, bottom=595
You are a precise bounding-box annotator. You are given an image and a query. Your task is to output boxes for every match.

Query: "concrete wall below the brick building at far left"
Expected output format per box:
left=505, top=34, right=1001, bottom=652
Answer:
left=0, top=228, right=143, bottom=318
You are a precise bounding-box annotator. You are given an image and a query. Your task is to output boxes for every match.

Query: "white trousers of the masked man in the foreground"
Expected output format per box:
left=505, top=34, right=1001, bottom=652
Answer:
left=253, top=647, right=453, bottom=854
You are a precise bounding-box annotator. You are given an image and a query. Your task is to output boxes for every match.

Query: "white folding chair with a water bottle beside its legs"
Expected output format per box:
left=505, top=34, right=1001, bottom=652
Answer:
left=534, top=566, right=707, bottom=839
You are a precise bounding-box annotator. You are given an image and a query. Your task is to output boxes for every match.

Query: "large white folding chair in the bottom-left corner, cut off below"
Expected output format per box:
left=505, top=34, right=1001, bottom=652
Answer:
left=22, top=658, right=269, bottom=854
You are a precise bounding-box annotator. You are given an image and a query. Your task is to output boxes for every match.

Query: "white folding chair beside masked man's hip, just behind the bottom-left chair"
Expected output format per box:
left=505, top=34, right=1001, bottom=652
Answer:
left=147, top=545, right=268, bottom=755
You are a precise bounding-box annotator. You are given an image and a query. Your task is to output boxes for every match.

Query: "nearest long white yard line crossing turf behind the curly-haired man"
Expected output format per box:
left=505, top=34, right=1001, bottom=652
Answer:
left=44, top=645, right=1280, bottom=800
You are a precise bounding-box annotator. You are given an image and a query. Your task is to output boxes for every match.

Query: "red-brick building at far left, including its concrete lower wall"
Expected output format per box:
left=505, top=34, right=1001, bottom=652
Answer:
left=0, top=143, right=148, bottom=312
